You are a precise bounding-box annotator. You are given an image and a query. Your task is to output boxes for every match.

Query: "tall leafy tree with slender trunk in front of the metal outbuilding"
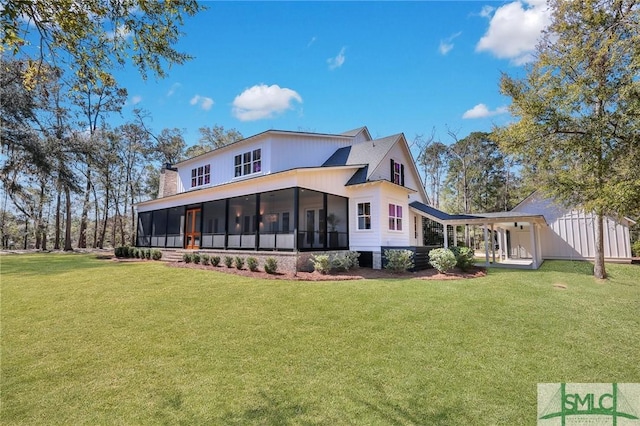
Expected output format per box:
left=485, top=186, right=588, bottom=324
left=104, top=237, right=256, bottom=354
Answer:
left=496, top=0, right=640, bottom=279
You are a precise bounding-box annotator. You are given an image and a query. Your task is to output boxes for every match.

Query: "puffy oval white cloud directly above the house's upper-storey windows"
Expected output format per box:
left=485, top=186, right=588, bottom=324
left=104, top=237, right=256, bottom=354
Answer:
left=232, top=84, right=302, bottom=121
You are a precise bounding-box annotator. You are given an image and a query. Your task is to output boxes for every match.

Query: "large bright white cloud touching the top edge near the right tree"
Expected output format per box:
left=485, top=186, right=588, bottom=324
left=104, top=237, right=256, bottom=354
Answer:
left=476, top=0, right=551, bottom=65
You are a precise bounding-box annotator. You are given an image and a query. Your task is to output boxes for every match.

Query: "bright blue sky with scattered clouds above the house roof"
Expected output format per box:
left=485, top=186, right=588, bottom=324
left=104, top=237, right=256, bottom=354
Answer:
left=116, top=0, right=549, bottom=150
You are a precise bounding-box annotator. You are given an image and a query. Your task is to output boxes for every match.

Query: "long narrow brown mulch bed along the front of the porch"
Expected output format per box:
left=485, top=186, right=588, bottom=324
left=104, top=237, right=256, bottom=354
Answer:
left=167, top=262, right=487, bottom=281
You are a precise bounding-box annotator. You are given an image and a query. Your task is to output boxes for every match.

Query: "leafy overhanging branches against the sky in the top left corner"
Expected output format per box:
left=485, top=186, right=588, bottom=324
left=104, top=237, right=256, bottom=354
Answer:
left=0, top=0, right=204, bottom=86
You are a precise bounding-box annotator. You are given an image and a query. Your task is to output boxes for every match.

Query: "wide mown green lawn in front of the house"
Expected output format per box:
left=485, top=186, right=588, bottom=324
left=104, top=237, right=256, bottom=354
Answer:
left=0, top=255, right=640, bottom=425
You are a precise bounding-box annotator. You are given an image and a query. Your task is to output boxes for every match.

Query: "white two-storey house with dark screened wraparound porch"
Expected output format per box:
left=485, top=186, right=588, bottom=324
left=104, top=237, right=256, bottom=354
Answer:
left=136, top=127, right=440, bottom=268
